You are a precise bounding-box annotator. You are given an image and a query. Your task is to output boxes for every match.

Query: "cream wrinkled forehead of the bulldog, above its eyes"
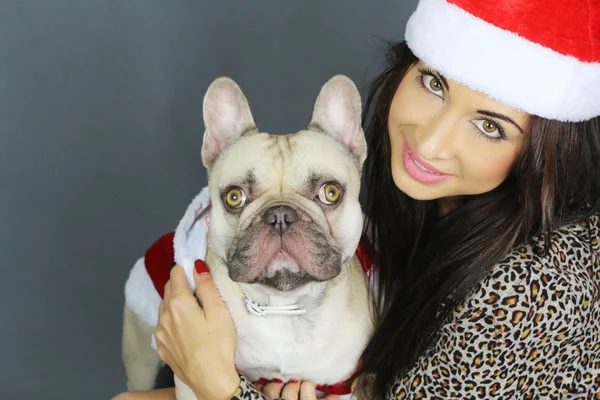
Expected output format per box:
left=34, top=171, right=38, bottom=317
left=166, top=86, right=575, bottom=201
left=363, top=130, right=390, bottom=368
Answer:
left=212, top=130, right=361, bottom=196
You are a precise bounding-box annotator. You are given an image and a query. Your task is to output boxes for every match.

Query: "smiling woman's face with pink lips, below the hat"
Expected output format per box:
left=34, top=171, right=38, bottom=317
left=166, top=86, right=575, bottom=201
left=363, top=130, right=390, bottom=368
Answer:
left=388, top=62, right=528, bottom=200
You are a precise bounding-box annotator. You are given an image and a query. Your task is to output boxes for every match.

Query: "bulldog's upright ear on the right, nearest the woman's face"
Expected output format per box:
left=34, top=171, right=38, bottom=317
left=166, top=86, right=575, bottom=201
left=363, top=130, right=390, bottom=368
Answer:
left=309, top=75, right=367, bottom=165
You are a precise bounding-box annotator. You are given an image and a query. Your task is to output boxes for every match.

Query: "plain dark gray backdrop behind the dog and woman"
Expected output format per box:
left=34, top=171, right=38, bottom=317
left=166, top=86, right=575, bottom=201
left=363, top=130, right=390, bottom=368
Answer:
left=0, top=0, right=416, bottom=400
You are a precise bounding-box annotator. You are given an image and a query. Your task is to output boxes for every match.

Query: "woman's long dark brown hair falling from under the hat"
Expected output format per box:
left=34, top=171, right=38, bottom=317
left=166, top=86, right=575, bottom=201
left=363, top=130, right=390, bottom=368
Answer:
left=358, top=42, right=600, bottom=398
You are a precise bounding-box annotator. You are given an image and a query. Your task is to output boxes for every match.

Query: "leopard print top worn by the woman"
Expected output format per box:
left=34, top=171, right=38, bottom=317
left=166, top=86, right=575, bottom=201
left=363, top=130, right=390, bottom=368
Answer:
left=234, top=216, right=600, bottom=400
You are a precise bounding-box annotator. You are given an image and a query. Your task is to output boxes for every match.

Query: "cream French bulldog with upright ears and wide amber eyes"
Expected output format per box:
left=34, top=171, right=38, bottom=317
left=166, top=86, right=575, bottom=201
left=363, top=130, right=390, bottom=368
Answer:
left=123, top=75, right=374, bottom=400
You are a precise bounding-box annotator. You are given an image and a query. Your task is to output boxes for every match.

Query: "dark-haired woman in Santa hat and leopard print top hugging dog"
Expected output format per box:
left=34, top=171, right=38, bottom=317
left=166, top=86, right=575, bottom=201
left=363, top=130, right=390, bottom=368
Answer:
left=115, top=0, right=600, bottom=400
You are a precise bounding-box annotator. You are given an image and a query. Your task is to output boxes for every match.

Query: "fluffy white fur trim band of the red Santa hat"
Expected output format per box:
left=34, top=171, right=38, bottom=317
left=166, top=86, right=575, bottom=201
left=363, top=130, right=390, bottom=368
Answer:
left=406, top=0, right=600, bottom=122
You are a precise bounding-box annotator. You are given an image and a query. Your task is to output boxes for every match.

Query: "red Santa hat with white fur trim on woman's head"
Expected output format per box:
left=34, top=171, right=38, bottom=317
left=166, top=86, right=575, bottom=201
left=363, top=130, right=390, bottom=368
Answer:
left=406, top=0, right=600, bottom=121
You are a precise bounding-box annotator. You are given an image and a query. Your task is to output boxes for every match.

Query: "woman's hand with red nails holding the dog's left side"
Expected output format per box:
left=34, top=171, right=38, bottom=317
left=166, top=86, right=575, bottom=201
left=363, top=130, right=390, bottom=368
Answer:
left=154, top=261, right=240, bottom=400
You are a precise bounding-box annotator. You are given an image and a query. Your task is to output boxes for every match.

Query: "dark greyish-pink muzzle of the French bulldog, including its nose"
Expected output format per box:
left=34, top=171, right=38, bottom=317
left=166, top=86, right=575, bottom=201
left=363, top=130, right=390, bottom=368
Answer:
left=227, top=205, right=343, bottom=292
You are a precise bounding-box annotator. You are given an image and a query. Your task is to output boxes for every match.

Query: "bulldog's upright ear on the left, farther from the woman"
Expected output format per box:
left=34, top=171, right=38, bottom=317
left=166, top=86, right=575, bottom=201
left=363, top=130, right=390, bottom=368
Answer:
left=202, top=77, right=257, bottom=168
